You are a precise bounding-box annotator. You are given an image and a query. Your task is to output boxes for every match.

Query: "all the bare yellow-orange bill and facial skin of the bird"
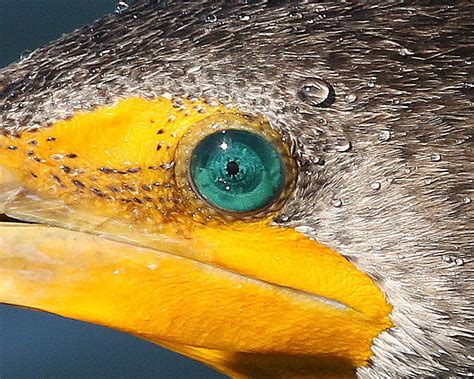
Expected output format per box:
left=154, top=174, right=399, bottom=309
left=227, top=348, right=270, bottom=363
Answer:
left=0, top=99, right=391, bottom=377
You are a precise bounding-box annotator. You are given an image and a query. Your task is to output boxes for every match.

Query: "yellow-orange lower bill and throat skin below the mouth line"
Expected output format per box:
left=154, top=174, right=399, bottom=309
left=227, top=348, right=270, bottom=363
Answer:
left=0, top=224, right=386, bottom=377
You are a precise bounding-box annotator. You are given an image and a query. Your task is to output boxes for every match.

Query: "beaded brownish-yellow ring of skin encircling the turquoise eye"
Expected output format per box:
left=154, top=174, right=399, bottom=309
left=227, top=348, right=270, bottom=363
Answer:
left=175, top=113, right=296, bottom=220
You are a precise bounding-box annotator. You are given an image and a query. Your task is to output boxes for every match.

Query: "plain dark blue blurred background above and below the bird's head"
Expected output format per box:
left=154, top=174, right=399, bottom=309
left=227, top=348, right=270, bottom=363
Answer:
left=0, top=0, right=223, bottom=379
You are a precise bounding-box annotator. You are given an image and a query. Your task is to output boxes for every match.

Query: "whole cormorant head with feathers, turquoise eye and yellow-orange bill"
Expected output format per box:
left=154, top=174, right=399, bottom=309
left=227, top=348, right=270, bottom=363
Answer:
left=0, top=2, right=473, bottom=377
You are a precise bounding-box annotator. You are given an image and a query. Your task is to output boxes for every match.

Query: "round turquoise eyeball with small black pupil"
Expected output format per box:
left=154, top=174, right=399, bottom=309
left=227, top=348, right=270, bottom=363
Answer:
left=190, top=129, right=284, bottom=212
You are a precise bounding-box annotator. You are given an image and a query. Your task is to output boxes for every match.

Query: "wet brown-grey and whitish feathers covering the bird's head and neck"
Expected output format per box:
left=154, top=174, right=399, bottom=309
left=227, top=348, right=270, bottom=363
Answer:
left=0, top=1, right=474, bottom=378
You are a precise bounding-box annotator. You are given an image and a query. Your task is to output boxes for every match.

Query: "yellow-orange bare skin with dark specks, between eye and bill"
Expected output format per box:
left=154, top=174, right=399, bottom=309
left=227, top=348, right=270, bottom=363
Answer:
left=0, top=98, right=232, bottom=225
